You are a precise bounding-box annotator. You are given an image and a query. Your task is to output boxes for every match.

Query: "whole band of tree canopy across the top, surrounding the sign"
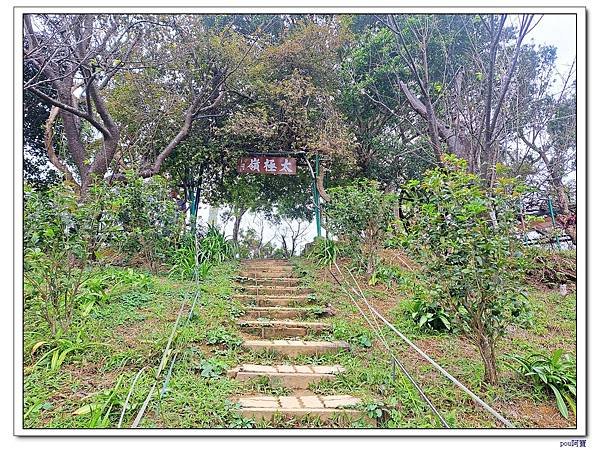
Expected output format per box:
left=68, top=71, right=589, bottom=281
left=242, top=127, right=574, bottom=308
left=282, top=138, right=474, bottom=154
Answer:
left=23, top=14, right=575, bottom=232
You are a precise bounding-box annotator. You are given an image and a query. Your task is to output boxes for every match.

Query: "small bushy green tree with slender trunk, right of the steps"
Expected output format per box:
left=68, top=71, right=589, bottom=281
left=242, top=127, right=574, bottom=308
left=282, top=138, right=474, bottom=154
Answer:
left=403, top=155, right=523, bottom=385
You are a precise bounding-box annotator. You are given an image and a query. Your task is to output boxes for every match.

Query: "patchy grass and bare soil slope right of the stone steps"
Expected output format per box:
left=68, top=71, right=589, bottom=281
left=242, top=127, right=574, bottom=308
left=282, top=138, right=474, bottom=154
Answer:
left=292, top=261, right=576, bottom=428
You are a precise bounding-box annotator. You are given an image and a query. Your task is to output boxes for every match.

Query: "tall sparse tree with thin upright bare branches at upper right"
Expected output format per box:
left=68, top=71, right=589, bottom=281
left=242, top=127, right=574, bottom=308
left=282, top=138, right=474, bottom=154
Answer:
left=381, top=14, right=537, bottom=184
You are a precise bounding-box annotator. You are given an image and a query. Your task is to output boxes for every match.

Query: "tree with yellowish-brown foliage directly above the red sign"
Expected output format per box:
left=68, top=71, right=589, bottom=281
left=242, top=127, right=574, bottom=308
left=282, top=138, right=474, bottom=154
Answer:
left=223, top=16, right=355, bottom=206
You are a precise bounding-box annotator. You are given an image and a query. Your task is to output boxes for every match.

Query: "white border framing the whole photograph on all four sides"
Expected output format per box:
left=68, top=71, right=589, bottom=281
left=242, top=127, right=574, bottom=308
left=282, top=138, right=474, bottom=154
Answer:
left=13, top=1, right=589, bottom=438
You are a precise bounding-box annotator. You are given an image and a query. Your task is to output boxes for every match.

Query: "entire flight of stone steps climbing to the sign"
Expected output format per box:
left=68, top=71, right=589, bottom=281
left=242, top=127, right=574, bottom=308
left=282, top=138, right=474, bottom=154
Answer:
left=228, top=259, right=364, bottom=423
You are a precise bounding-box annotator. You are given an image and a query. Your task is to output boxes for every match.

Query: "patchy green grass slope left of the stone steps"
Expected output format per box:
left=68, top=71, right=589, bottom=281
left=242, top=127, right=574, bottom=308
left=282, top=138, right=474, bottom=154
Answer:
left=24, top=263, right=247, bottom=428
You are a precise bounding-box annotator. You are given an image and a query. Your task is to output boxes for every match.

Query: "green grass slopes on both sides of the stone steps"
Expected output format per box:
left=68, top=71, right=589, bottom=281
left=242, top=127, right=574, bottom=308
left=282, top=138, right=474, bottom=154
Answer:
left=24, top=258, right=575, bottom=428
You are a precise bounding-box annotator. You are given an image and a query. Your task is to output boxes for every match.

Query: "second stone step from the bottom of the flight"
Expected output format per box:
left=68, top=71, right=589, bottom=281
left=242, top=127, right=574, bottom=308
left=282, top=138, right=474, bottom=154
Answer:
left=227, top=364, right=345, bottom=389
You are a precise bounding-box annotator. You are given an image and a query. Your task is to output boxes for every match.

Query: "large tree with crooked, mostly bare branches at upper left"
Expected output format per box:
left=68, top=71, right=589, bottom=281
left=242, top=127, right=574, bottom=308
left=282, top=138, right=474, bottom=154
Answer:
left=24, top=14, right=251, bottom=195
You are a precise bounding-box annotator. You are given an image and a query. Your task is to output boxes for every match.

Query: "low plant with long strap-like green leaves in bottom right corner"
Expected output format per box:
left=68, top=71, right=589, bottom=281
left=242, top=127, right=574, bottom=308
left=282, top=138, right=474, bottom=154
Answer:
left=507, top=349, right=577, bottom=418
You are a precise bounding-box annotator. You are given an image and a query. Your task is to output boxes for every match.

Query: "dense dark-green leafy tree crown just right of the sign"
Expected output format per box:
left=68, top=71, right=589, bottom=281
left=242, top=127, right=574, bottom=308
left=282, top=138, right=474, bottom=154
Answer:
left=339, top=20, right=436, bottom=186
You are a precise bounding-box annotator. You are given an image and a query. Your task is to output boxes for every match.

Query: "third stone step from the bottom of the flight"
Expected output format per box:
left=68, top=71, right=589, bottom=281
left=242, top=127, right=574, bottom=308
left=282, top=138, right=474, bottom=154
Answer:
left=242, top=339, right=350, bottom=357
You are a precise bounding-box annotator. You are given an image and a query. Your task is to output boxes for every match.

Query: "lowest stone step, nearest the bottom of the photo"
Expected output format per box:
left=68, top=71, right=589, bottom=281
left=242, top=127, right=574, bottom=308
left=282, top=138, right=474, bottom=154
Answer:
left=237, top=395, right=364, bottom=421
